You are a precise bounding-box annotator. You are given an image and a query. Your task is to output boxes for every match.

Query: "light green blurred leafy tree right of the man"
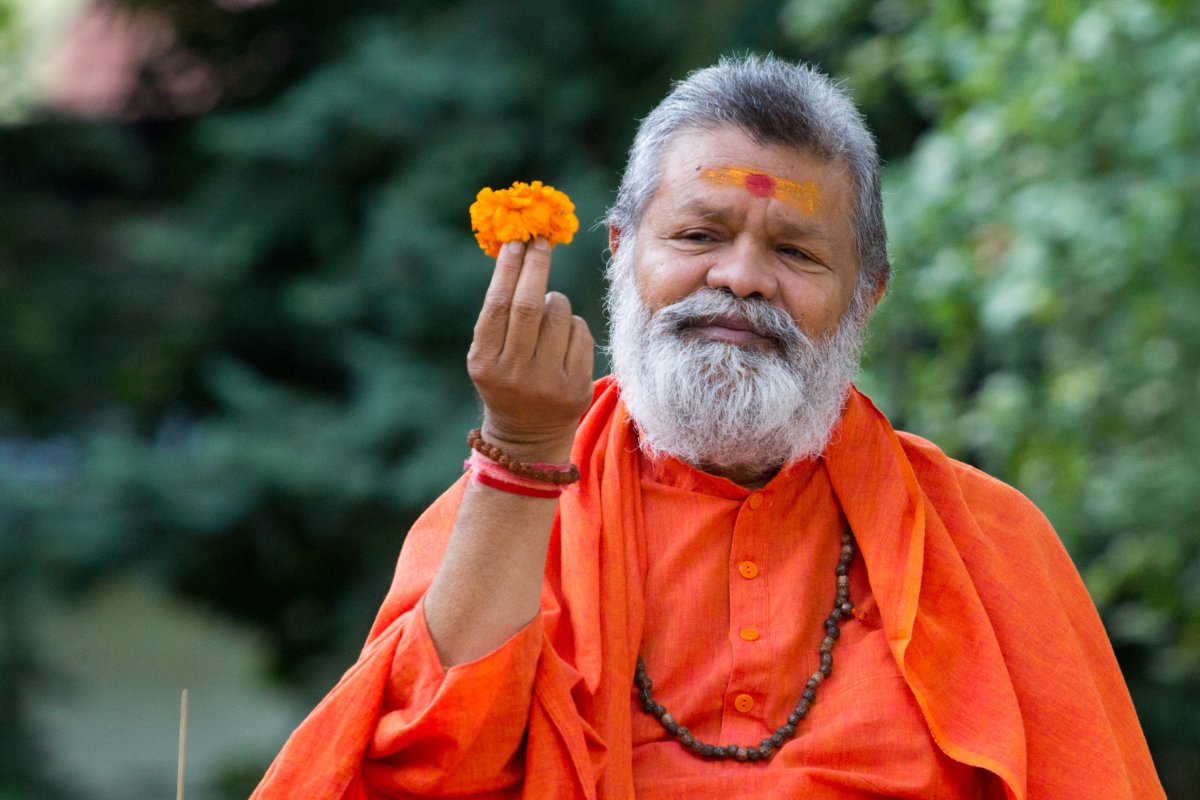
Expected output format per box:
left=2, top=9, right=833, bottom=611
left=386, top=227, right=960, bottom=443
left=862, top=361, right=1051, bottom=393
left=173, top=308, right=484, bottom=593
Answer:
left=787, top=0, right=1200, bottom=796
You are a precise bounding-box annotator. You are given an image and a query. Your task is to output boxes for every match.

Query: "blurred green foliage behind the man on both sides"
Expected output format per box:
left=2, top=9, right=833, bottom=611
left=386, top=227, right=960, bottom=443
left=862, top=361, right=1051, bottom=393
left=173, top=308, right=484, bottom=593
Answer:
left=0, top=0, right=1200, bottom=798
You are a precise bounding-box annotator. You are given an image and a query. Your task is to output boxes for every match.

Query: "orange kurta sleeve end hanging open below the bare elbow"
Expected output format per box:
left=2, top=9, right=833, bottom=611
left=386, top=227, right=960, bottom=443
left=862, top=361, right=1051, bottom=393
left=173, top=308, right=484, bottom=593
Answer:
left=362, top=599, right=541, bottom=798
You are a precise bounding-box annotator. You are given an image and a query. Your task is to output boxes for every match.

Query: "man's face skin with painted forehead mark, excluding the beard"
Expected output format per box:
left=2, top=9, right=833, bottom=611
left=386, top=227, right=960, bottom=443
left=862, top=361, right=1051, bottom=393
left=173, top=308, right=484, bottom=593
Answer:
left=618, top=127, right=858, bottom=348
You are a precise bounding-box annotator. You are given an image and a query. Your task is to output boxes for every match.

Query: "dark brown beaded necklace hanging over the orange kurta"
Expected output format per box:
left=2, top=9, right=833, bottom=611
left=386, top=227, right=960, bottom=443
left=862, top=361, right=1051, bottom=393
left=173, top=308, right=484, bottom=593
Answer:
left=634, top=530, right=854, bottom=762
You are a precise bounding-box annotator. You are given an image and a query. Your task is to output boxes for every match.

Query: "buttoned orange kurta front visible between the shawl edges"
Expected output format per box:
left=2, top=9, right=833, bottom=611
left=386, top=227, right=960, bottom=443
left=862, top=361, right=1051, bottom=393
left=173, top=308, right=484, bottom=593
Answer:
left=632, top=448, right=988, bottom=800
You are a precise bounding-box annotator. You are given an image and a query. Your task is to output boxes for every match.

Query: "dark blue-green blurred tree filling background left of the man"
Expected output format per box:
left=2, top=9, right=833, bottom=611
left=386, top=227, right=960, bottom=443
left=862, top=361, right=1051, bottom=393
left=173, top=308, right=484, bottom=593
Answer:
left=0, top=0, right=798, bottom=794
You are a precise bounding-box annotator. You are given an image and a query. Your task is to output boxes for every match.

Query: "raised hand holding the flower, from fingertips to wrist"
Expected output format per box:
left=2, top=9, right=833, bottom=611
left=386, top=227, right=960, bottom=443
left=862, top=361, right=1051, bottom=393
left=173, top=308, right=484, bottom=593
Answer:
left=467, top=237, right=595, bottom=462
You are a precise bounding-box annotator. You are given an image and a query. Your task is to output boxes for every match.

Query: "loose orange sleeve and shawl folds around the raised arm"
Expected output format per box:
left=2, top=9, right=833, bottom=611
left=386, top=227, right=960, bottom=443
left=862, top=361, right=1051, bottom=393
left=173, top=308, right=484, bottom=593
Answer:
left=251, top=481, right=561, bottom=800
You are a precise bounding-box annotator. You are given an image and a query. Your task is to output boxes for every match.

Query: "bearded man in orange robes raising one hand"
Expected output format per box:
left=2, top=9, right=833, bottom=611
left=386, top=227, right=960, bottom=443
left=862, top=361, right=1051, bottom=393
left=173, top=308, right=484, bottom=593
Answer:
left=256, top=59, right=1163, bottom=800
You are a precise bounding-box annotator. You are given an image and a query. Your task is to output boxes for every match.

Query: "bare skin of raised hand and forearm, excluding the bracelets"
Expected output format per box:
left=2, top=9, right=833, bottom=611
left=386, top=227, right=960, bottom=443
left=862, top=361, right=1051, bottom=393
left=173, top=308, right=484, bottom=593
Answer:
left=425, top=240, right=594, bottom=680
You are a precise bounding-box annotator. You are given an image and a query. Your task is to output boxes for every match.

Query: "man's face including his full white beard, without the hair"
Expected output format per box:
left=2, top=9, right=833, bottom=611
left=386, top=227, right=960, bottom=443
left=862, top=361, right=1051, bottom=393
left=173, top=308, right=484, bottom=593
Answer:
left=608, top=130, right=870, bottom=485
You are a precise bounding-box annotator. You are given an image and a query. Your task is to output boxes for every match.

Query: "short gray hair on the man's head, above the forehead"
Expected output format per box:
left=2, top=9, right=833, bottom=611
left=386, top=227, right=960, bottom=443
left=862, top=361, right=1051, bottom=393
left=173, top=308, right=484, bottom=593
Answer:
left=607, top=55, right=892, bottom=301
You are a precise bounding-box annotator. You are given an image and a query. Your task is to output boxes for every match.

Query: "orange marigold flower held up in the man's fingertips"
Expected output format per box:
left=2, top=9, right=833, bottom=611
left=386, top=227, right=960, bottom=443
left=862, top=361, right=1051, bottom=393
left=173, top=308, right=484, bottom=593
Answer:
left=470, top=181, right=580, bottom=258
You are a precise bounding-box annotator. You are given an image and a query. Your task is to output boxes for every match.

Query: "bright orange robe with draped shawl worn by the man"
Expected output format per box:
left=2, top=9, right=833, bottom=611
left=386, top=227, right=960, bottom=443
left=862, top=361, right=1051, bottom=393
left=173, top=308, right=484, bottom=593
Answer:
left=253, top=379, right=1164, bottom=800
